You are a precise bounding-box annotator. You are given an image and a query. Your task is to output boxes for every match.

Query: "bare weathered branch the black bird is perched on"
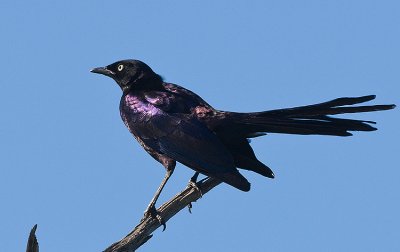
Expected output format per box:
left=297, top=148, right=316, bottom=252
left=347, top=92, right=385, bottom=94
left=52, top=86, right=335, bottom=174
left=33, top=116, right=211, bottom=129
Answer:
left=104, top=178, right=221, bottom=252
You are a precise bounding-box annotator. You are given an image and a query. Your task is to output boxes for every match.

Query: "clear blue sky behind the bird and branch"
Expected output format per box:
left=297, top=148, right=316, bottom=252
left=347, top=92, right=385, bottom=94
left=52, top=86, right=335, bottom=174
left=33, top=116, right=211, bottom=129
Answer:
left=0, top=0, right=400, bottom=252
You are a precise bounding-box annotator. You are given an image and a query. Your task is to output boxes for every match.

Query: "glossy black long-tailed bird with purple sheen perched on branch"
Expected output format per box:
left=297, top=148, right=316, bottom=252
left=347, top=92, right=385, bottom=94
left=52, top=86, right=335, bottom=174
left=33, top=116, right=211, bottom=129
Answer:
left=91, top=60, right=395, bottom=217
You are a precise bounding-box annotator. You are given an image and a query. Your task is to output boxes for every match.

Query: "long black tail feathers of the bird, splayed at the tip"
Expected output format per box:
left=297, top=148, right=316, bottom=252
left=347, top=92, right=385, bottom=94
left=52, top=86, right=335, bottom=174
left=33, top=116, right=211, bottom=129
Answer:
left=230, top=95, right=395, bottom=138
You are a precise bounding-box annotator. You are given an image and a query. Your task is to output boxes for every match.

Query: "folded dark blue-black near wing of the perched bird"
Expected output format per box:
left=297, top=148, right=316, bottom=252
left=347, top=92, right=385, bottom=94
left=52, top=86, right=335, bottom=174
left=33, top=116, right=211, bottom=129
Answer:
left=142, top=114, right=250, bottom=191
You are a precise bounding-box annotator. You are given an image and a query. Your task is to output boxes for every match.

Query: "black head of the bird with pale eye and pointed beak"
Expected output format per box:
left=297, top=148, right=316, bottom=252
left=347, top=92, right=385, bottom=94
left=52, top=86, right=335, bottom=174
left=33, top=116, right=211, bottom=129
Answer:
left=90, top=60, right=162, bottom=92
